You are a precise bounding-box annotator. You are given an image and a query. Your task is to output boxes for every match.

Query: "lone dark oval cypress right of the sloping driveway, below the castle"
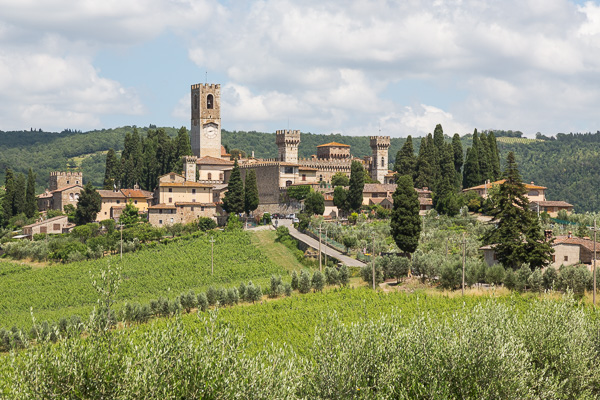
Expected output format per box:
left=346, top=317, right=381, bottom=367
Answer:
left=390, top=175, right=422, bottom=254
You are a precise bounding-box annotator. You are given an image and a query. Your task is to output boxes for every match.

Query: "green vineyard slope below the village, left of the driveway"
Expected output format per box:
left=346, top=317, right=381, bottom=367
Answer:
left=0, top=232, right=295, bottom=328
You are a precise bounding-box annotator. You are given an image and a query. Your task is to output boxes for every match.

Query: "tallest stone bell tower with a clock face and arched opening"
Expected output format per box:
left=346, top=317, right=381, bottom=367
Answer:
left=190, top=83, right=221, bottom=158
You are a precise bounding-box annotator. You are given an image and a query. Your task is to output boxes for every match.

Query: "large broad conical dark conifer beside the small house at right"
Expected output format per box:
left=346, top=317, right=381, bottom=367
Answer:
left=483, top=152, right=553, bottom=270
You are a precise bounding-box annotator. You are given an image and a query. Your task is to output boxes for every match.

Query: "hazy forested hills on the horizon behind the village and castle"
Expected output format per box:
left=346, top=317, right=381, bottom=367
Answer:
left=0, top=126, right=600, bottom=212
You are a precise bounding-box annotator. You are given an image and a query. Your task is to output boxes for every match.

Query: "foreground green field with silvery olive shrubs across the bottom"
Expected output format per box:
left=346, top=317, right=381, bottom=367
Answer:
left=0, top=289, right=600, bottom=399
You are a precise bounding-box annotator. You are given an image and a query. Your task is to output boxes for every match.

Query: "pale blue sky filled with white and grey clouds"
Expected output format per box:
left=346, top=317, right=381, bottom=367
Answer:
left=0, top=0, right=600, bottom=137
